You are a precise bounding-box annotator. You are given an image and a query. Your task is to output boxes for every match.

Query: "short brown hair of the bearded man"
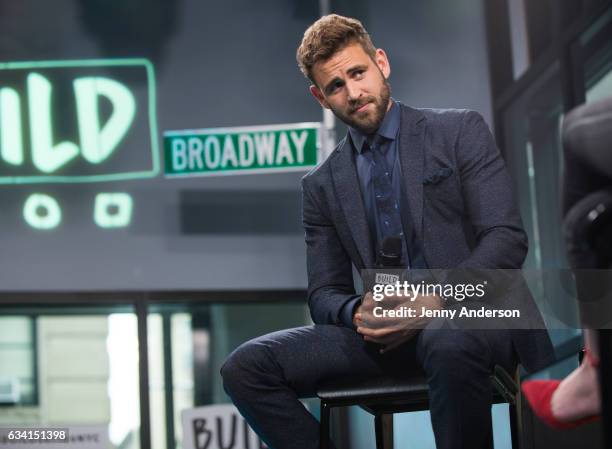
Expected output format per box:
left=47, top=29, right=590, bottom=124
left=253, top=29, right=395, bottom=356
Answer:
left=296, top=14, right=376, bottom=84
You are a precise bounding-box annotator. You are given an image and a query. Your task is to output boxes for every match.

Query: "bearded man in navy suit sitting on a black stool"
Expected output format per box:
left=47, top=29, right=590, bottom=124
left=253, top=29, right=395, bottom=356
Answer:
left=221, top=15, right=552, bottom=449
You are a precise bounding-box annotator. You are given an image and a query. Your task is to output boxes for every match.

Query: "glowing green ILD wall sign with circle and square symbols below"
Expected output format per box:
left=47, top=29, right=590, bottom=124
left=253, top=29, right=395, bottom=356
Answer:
left=0, top=59, right=159, bottom=230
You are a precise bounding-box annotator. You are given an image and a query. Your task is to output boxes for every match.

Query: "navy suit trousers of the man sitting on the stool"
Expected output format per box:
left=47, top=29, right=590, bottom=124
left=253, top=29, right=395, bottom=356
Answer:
left=221, top=319, right=517, bottom=449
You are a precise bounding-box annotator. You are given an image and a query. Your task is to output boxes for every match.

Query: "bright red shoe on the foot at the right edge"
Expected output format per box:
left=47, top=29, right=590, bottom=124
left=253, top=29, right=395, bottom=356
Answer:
left=521, top=351, right=601, bottom=430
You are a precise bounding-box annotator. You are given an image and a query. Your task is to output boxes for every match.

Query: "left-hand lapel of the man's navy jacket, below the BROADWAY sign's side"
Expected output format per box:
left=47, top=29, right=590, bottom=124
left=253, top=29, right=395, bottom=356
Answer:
left=331, top=136, right=375, bottom=268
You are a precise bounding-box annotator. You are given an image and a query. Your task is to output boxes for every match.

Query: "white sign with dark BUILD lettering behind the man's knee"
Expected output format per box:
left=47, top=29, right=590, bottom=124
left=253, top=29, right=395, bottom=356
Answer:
left=182, top=404, right=268, bottom=449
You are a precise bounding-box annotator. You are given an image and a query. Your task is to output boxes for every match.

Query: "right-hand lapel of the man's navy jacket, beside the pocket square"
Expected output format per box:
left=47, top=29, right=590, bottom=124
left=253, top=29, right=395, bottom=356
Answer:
left=399, top=105, right=426, bottom=247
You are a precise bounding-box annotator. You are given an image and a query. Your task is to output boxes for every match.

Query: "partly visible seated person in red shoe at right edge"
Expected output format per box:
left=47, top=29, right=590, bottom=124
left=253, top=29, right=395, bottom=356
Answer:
left=522, top=97, right=612, bottom=429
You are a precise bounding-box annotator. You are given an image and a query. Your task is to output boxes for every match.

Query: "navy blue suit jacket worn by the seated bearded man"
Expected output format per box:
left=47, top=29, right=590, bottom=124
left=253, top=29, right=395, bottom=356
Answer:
left=302, top=105, right=553, bottom=370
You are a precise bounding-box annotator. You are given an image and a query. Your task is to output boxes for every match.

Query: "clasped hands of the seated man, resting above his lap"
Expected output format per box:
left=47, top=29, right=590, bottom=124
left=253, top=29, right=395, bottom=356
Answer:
left=353, top=292, right=443, bottom=353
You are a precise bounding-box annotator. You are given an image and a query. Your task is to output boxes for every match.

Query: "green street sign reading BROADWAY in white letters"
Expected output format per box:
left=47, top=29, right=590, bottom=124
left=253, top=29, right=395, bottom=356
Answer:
left=164, top=123, right=321, bottom=177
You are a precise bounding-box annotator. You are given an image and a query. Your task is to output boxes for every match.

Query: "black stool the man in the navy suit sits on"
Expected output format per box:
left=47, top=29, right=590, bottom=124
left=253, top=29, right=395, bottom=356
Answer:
left=317, top=366, right=519, bottom=449
